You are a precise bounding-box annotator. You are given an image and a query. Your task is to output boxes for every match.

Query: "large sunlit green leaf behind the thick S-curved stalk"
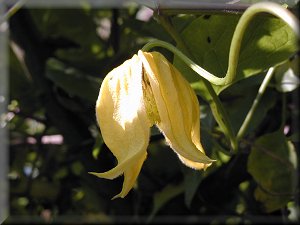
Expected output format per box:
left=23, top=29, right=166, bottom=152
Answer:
left=174, top=15, right=297, bottom=97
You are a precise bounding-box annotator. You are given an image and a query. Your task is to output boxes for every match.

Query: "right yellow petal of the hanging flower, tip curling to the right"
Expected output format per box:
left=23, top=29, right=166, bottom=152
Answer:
left=138, top=51, right=214, bottom=169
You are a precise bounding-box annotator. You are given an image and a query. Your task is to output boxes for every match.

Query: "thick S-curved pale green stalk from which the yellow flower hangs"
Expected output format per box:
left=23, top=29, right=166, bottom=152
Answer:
left=142, top=2, right=300, bottom=85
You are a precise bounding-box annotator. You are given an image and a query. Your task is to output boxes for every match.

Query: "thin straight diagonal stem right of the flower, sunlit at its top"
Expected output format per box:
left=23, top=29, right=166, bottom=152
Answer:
left=237, top=67, right=274, bottom=140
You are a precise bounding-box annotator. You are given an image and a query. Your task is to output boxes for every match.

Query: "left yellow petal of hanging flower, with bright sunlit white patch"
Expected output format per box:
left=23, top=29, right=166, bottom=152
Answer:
left=92, top=55, right=150, bottom=197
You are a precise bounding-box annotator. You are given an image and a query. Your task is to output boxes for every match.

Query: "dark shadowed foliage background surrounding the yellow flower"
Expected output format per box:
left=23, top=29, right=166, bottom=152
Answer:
left=4, top=3, right=299, bottom=224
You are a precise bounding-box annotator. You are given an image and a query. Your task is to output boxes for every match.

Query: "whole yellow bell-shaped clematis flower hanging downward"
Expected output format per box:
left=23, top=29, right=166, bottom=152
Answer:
left=91, top=51, right=214, bottom=198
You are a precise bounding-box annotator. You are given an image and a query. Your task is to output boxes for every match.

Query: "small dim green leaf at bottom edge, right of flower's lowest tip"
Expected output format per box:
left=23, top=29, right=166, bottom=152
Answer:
left=147, top=184, right=184, bottom=222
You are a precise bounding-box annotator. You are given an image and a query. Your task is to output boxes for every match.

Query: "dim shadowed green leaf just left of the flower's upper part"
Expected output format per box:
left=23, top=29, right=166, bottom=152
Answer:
left=46, top=59, right=101, bottom=102
